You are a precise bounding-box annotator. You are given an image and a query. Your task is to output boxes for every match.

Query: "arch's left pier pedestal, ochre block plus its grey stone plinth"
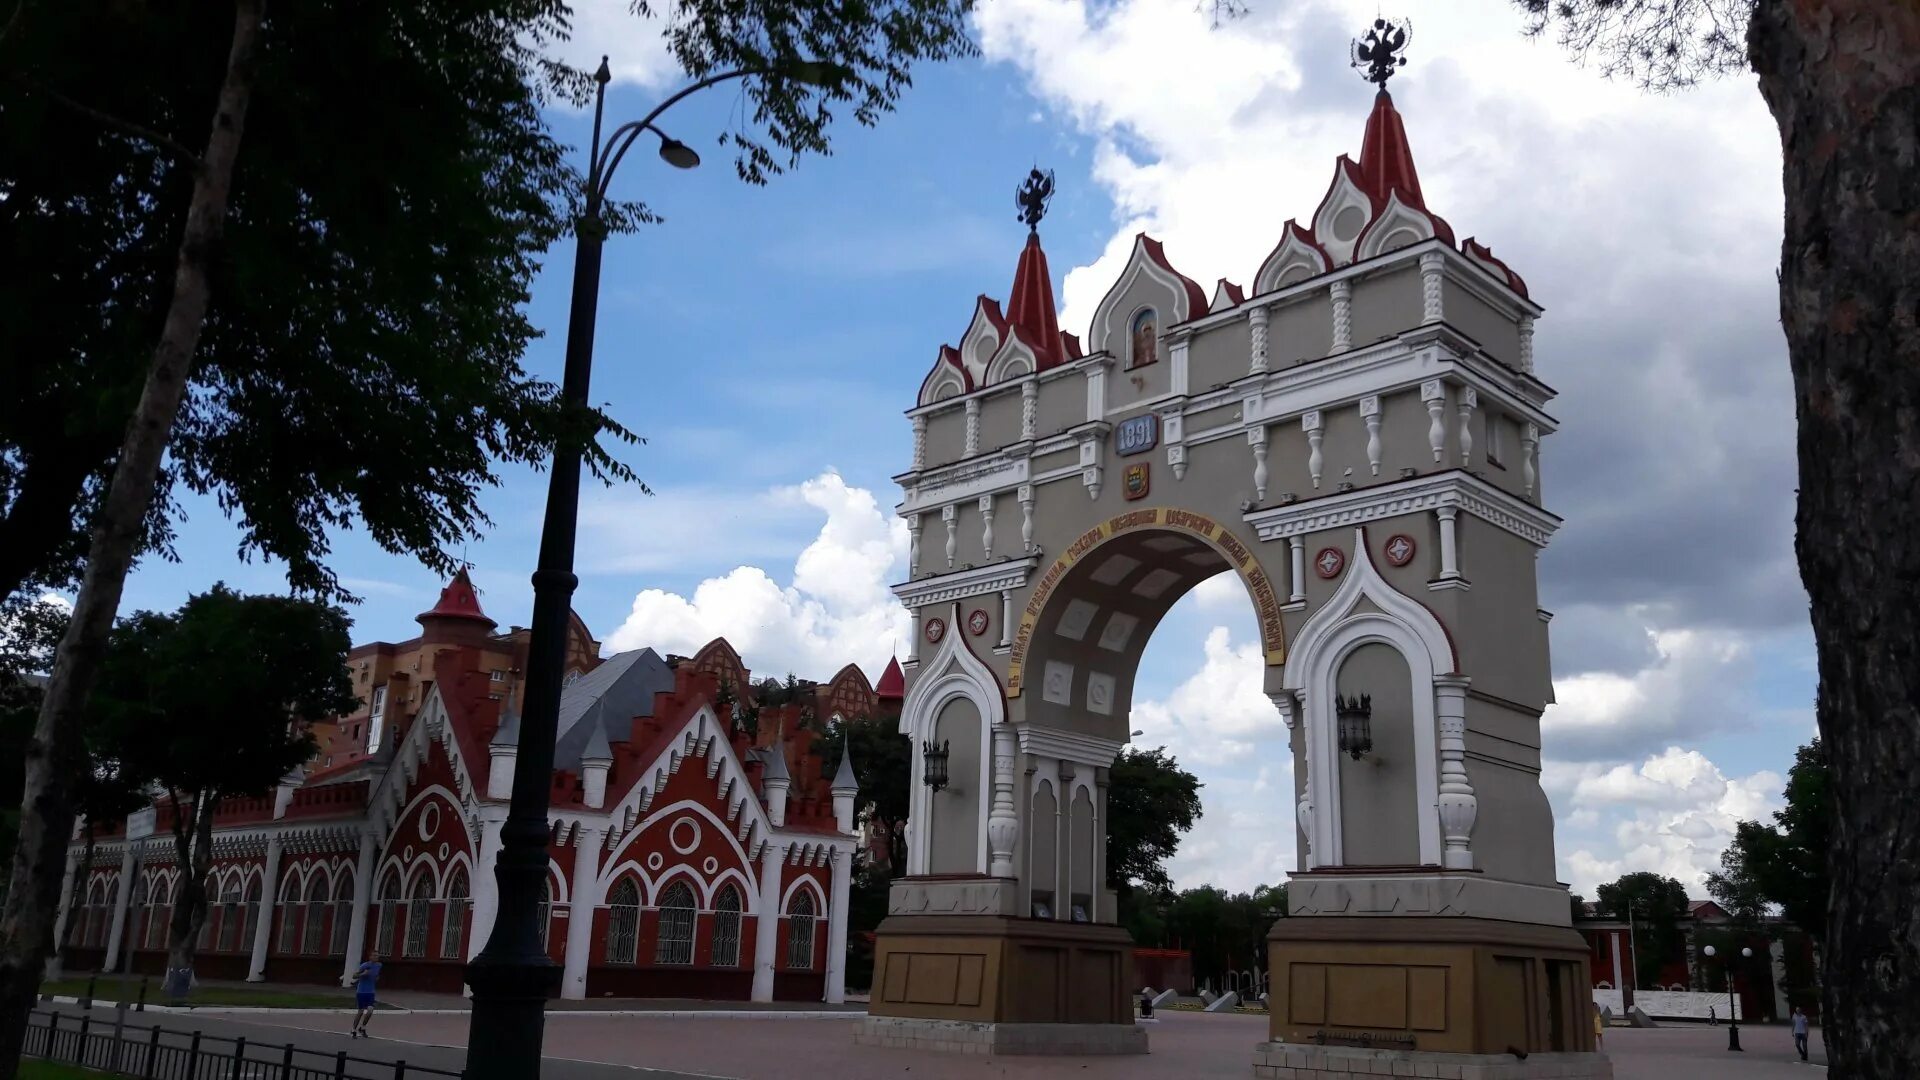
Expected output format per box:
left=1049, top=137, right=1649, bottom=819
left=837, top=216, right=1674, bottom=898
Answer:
left=856, top=915, right=1146, bottom=1053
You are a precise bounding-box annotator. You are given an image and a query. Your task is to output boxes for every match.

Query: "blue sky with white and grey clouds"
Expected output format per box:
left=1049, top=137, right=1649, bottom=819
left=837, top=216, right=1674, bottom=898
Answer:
left=105, top=0, right=1816, bottom=897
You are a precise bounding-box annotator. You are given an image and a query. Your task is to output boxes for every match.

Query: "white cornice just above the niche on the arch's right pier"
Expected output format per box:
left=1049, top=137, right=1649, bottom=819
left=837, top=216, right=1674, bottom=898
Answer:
left=1246, top=471, right=1561, bottom=548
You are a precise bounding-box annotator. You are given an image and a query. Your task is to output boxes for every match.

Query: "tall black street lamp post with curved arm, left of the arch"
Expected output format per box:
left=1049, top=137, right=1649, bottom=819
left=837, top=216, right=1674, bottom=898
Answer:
left=467, top=58, right=845, bottom=1080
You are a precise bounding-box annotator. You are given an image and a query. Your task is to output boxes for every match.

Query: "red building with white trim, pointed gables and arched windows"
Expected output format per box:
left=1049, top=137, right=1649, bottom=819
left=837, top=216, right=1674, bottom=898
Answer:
left=60, top=575, right=900, bottom=1001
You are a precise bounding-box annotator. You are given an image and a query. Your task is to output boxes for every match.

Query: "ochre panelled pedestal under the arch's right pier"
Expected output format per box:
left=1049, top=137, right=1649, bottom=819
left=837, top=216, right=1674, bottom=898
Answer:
left=1267, top=915, right=1605, bottom=1076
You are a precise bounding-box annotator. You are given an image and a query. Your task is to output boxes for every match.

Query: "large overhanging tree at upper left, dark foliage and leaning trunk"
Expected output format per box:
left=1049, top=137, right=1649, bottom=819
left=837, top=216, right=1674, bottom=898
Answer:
left=0, top=0, right=972, bottom=1060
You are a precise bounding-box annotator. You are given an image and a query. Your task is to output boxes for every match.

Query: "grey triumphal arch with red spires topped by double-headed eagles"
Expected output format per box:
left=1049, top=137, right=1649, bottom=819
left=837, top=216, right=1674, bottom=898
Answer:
left=858, top=25, right=1609, bottom=1076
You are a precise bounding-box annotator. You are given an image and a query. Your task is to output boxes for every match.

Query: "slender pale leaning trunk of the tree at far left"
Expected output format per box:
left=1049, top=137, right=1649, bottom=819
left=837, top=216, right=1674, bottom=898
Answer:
left=0, top=0, right=265, bottom=1080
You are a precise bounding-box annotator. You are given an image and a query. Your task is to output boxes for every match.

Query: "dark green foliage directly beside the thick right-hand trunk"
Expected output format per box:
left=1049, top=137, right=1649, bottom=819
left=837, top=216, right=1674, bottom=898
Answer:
left=1707, top=738, right=1834, bottom=942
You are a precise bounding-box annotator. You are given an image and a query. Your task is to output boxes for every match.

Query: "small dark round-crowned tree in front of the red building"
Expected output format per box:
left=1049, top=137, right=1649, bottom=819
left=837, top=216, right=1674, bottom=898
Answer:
left=100, top=586, right=355, bottom=992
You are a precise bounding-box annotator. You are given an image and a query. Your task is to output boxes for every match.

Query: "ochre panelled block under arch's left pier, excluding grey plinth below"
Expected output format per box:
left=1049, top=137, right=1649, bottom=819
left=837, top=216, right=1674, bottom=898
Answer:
left=868, top=915, right=1133, bottom=1028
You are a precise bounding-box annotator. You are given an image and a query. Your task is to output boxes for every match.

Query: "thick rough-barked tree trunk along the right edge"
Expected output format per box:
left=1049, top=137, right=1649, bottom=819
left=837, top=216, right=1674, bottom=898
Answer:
left=1749, top=0, right=1920, bottom=1080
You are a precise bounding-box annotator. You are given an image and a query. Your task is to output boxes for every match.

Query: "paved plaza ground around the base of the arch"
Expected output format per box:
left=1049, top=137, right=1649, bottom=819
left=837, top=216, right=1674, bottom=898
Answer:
left=45, top=1009, right=1826, bottom=1080
